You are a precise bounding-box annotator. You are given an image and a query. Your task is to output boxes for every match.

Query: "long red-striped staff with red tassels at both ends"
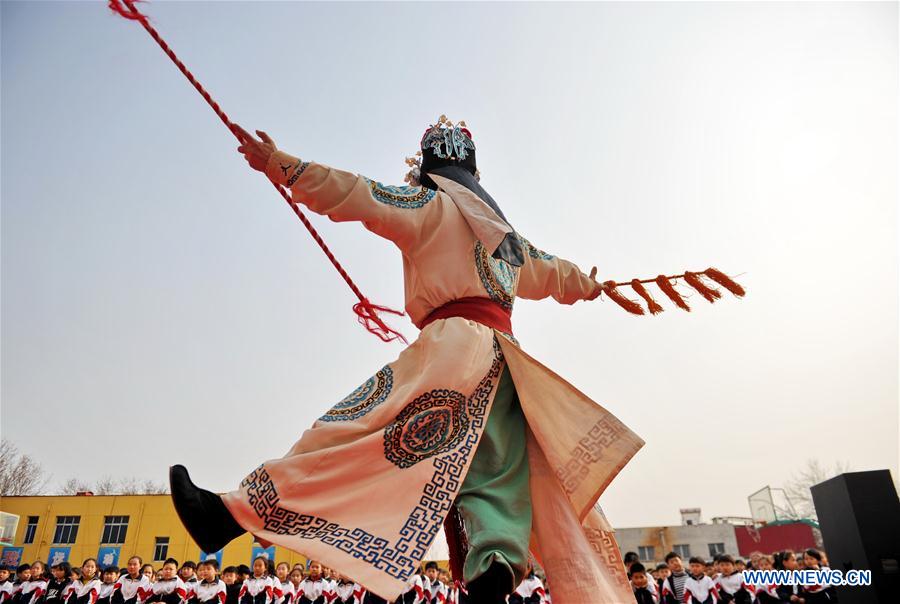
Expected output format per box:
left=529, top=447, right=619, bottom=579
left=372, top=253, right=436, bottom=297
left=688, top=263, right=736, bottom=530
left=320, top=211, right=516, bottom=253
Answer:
left=109, top=0, right=408, bottom=343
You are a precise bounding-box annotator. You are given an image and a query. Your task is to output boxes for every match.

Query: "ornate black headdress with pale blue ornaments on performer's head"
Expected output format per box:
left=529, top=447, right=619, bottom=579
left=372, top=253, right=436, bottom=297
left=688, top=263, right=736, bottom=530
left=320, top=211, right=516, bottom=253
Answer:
left=404, top=115, right=480, bottom=186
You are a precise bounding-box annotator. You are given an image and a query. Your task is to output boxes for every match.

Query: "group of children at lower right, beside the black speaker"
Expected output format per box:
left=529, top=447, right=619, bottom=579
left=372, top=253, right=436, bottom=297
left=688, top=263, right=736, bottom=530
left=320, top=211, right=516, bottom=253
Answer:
left=625, top=549, right=837, bottom=604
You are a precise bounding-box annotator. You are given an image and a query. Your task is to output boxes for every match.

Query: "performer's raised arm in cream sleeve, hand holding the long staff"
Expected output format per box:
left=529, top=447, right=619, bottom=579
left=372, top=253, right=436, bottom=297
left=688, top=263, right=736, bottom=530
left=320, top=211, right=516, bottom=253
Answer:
left=238, top=130, right=438, bottom=249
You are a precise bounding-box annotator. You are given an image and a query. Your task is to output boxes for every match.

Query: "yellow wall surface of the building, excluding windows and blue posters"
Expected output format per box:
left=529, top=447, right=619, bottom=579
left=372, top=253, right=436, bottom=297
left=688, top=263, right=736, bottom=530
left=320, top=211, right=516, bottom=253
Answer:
left=0, top=495, right=306, bottom=568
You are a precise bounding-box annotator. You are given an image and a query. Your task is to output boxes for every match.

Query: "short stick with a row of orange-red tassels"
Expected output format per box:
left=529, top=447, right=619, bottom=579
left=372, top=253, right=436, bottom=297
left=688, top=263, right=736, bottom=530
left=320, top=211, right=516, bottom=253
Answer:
left=602, top=268, right=746, bottom=315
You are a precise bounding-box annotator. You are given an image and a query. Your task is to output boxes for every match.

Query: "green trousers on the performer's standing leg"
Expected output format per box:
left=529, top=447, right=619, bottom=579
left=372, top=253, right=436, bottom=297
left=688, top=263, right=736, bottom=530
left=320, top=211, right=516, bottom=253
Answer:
left=456, top=367, right=531, bottom=585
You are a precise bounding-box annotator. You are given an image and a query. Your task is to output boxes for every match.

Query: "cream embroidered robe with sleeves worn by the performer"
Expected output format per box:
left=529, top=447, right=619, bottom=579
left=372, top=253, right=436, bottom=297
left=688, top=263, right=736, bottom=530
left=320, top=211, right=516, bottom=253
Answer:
left=223, top=151, right=643, bottom=604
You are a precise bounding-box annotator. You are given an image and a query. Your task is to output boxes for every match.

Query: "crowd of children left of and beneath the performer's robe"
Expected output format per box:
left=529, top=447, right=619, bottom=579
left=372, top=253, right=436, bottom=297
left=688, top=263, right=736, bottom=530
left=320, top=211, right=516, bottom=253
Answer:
left=0, top=556, right=550, bottom=604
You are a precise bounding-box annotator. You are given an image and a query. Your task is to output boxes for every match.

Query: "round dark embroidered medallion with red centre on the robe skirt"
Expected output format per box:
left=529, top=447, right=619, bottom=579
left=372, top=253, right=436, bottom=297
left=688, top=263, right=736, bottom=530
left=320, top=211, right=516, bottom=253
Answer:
left=384, top=389, right=469, bottom=468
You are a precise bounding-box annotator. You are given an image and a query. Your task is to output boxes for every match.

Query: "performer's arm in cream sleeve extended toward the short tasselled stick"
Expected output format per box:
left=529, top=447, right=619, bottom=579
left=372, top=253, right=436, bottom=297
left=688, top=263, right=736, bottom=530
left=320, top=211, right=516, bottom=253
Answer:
left=516, top=236, right=602, bottom=304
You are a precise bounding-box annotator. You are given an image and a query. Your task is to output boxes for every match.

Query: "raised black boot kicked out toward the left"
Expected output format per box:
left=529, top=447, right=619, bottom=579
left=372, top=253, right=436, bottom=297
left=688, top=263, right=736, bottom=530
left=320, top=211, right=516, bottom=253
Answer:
left=169, top=465, right=247, bottom=553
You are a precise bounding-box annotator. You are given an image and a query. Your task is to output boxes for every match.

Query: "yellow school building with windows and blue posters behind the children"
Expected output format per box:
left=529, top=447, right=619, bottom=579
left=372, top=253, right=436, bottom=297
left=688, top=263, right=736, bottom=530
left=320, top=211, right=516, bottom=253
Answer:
left=0, top=493, right=306, bottom=568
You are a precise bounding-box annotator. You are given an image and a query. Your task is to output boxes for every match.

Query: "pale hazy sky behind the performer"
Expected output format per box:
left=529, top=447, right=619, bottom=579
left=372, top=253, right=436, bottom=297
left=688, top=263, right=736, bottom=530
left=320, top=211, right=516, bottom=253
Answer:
left=0, top=1, right=900, bottom=526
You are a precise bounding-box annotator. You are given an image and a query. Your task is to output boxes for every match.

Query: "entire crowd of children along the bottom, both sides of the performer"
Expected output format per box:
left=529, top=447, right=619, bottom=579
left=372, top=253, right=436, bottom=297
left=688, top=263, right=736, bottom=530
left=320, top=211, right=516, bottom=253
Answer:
left=0, top=549, right=837, bottom=604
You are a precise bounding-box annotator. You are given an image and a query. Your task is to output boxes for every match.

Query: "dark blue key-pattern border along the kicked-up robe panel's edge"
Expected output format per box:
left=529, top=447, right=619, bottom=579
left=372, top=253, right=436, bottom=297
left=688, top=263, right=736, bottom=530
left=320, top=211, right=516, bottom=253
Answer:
left=241, top=339, right=504, bottom=581
